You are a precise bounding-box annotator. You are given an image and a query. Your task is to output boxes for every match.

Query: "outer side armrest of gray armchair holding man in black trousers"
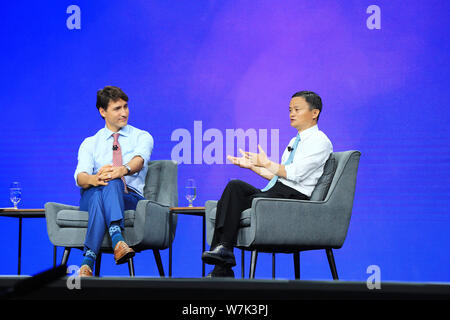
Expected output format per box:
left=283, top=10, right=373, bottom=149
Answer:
left=251, top=198, right=350, bottom=248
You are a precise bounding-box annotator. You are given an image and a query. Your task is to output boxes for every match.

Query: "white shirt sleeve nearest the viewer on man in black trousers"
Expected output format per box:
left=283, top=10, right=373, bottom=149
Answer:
left=285, top=140, right=333, bottom=183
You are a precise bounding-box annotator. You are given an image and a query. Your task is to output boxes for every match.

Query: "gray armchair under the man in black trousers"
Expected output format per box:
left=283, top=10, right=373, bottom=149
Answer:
left=205, top=151, right=361, bottom=280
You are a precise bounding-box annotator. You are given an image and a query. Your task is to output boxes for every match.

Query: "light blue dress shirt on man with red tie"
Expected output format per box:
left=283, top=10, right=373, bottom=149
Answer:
left=74, top=125, right=153, bottom=196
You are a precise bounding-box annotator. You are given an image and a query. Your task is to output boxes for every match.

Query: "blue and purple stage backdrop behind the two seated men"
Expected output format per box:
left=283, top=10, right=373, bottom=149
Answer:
left=0, top=0, right=450, bottom=281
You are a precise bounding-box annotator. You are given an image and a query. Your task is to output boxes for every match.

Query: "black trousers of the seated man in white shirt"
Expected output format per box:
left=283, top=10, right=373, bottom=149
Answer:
left=211, top=180, right=309, bottom=248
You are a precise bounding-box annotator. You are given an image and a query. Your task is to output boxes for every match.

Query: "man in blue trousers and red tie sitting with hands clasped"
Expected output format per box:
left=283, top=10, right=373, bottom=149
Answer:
left=74, top=86, right=153, bottom=276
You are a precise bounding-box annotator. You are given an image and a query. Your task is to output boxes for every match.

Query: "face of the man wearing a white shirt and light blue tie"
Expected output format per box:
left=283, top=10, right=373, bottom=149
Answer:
left=289, top=97, right=319, bottom=131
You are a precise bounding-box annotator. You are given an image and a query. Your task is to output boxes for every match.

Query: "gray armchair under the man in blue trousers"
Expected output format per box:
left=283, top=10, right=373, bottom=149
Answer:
left=45, top=160, right=178, bottom=277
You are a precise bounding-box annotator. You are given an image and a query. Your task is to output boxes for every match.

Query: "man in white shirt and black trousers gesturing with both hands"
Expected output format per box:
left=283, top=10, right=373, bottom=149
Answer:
left=202, top=91, right=333, bottom=277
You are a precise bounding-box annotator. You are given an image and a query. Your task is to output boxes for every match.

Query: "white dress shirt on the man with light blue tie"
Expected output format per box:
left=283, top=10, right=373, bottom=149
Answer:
left=278, top=125, right=333, bottom=197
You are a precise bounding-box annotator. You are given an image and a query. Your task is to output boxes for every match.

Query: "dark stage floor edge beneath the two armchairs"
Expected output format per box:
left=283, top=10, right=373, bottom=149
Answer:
left=0, top=276, right=450, bottom=302
